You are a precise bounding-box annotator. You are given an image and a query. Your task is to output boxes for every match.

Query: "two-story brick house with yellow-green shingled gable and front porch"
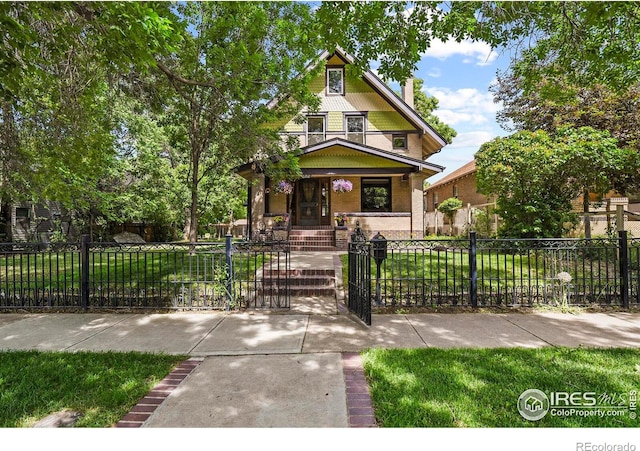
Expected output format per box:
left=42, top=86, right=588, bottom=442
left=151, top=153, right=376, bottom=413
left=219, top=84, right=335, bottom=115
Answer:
left=239, top=49, right=446, bottom=249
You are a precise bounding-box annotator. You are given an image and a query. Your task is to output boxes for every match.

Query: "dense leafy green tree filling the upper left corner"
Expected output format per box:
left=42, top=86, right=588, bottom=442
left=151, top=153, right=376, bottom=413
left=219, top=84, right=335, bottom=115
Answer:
left=0, top=2, right=179, bottom=237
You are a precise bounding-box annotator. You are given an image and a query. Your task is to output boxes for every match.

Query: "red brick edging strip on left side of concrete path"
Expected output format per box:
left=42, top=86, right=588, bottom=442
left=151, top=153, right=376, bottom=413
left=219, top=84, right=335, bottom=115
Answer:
left=115, top=358, right=202, bottom=428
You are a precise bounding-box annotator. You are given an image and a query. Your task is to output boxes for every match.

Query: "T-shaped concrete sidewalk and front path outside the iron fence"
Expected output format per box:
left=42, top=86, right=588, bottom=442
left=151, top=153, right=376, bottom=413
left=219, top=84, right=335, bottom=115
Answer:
left=0, top=252, right=640, bottom=427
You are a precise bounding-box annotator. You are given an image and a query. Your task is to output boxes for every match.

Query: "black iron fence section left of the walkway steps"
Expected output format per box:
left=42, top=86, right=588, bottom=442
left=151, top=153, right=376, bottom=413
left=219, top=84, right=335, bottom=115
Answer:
left=0, top=236, right=290, bottom=311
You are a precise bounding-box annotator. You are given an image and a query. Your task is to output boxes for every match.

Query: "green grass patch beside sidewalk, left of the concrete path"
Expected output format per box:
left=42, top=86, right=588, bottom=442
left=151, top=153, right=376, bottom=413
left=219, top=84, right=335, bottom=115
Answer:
left=0, top=351, right=186, bottom=428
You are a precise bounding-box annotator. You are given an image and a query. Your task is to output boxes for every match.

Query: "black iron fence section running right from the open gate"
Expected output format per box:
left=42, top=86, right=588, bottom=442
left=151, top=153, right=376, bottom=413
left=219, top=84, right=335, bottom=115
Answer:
left=348, top=232, right=640, bottom=309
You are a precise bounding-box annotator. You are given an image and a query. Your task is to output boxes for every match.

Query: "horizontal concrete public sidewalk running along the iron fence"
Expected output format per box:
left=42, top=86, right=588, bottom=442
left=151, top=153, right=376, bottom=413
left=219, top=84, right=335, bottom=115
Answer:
left=0, top=308, right=640, bottom=357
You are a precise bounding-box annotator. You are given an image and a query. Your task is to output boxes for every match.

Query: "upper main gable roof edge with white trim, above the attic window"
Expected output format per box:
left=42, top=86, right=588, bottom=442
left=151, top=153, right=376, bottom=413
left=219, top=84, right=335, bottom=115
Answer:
left=318, top=47, right=447, bottom=148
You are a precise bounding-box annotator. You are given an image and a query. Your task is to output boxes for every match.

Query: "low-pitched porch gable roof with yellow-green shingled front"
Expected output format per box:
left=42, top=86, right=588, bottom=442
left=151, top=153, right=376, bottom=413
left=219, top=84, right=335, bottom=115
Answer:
left=300, top=138, right=444, bottom=174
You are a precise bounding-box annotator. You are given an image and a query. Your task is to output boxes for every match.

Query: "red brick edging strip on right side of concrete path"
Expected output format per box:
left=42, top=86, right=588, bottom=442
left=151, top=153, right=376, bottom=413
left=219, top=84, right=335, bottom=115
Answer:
left=342, top=352, right=378, bottom=428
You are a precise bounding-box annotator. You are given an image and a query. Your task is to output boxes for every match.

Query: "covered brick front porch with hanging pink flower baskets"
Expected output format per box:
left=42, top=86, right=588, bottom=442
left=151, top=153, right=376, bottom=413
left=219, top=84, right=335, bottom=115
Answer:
left=238, top=139, right=442, bottom=246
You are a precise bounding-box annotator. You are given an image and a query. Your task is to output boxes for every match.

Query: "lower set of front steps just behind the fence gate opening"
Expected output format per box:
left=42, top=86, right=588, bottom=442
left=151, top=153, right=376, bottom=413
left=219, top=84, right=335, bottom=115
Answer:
left=262, top=269, right=336, bottom=298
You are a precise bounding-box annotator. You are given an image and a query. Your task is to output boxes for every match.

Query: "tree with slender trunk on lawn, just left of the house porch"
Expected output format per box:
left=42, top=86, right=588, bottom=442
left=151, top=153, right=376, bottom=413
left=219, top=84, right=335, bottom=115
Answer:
left=157, top=2, right=318, bottom=242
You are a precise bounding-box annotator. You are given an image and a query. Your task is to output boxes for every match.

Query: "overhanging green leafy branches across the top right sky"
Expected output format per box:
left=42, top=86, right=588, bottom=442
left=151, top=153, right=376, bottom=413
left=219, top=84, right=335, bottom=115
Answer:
left=316, top=1, right=640, bottom=90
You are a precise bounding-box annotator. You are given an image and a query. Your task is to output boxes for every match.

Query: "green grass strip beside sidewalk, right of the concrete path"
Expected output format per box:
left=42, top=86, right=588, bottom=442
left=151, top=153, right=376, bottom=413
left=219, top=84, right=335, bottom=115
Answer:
left=362, top=348, right=640, bottom=428
